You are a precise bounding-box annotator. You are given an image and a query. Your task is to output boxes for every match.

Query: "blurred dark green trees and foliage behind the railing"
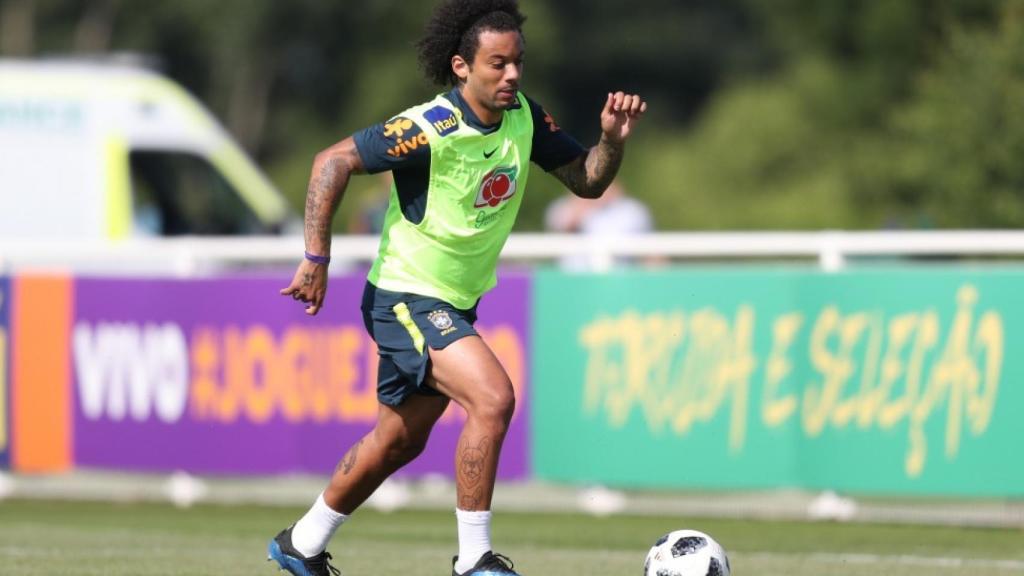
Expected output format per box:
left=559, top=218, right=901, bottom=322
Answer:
left=0, top=0, right=1024, bottom=231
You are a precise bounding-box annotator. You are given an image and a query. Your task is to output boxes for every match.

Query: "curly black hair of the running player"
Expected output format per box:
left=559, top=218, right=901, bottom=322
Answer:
left=416, top=0, right=526, bottom=86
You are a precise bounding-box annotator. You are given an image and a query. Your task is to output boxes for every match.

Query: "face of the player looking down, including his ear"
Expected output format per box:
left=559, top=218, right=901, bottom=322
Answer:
left=452, top=30, right=524, bottom=122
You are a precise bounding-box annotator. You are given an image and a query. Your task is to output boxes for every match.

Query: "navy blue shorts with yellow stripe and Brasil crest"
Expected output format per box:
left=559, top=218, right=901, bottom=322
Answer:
left=361, top=282, right=476, bottom=406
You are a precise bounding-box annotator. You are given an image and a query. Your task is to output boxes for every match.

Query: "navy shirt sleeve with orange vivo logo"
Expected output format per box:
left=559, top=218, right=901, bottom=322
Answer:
left=352, top=116, right=430, bottom=174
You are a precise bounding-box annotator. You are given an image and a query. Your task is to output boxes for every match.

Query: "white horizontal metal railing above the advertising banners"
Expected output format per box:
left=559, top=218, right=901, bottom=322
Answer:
left=0, top=231, right=1024, bottom=276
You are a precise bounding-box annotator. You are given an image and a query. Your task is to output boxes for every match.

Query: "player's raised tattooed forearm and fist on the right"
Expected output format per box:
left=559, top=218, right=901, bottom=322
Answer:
left=551, top=92, right=647, bottom=198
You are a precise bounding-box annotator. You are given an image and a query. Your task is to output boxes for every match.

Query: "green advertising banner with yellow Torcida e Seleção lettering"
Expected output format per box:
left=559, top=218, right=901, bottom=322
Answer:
left=532, top=266, right=1024, bottom=496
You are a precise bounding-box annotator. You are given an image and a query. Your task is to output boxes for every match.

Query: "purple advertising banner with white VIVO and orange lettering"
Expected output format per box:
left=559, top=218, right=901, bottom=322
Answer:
left=71, top=273, right=530, bottom=480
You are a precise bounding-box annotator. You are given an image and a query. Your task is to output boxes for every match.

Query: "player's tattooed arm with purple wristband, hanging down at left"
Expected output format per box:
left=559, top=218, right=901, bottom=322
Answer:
left=281, top=137, right=365, bottom=316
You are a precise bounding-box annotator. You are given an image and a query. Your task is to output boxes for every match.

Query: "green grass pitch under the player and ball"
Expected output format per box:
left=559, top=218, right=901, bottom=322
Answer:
left=0, top=500, right=1024, bottom=576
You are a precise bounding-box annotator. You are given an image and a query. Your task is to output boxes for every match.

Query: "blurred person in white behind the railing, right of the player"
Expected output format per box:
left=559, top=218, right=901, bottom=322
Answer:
left=544, top=180, right=654, bottom=272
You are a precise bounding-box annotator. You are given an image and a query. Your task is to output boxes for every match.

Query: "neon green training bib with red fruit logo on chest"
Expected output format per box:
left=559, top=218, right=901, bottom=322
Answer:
left=369, top=94, right=534, bottom=308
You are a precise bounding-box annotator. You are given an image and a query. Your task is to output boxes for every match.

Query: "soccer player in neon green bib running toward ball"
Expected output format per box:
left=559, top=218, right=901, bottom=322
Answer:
left=269, top=0, right=646, bottom=576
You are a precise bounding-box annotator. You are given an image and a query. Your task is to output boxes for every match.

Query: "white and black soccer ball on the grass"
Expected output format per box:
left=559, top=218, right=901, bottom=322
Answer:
left=643, top=530, right=729, bottom=576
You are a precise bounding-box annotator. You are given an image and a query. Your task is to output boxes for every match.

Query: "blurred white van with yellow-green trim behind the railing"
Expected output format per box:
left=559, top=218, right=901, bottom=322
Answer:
left=0, top=59, right=294, bottom=240
